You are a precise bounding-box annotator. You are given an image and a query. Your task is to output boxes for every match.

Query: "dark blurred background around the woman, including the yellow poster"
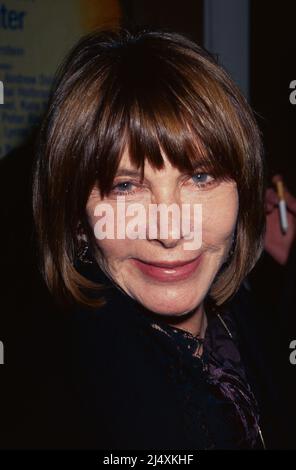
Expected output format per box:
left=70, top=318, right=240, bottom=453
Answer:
left=0, top=0, right=296, bottom=449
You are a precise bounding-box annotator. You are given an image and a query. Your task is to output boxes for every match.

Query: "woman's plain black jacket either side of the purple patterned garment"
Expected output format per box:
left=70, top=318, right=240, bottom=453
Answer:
left=60, top=267, right=286, bottom=450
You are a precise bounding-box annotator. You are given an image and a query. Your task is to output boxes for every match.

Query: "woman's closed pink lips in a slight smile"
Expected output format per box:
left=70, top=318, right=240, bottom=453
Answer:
left=132, top=255, right=202, bottom=282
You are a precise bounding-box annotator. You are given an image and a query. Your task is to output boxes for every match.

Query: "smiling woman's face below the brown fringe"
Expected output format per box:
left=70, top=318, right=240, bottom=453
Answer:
left=86, top=150, right=238, bottom=315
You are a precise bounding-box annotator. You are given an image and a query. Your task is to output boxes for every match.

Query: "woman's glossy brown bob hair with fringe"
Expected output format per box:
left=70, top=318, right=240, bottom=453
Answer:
left=33, top=28, right=265, bottom=307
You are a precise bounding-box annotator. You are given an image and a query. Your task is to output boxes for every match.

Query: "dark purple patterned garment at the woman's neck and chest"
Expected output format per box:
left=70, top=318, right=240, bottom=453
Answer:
left=142, top=302, right=260, bottom=449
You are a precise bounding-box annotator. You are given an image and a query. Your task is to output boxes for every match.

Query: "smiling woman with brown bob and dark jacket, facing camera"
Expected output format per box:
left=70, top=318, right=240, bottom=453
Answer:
left=34, top=26, right=270, bottom=449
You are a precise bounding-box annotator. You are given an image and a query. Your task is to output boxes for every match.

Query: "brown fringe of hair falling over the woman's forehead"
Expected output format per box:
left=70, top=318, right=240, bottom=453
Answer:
left=82, top=45, right=244, bottom=197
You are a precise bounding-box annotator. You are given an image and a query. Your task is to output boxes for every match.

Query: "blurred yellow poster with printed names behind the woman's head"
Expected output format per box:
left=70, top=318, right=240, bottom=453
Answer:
left=0, top=0, right=120, bottom=157
